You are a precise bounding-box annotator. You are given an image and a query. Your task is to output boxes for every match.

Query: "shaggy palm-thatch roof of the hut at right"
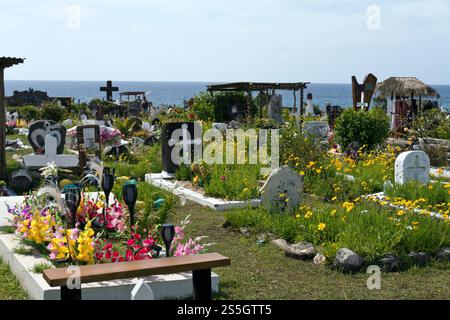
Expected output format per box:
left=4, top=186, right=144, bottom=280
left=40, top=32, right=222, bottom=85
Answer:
left=376, top=77, right=440, bottom=98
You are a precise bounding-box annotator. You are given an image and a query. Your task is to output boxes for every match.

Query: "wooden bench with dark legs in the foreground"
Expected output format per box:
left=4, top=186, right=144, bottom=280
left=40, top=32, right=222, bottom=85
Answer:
left=43, top=253, right=231, bottom=300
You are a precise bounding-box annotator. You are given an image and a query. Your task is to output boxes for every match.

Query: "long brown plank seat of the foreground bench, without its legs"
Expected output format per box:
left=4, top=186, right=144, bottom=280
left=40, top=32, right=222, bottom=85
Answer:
left=43, top=253, right=231, bottom=287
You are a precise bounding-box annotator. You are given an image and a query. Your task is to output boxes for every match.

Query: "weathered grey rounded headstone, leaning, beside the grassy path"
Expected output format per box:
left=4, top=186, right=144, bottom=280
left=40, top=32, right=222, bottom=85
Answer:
left=261, top=166, right=303, bottom=211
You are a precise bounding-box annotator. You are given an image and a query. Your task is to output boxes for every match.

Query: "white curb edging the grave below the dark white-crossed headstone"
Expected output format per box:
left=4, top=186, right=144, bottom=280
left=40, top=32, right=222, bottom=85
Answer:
left=145, top=173, right=261, bottom=211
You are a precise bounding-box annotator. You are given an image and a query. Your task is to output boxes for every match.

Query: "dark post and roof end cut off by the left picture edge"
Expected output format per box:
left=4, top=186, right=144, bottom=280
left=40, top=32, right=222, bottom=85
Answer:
left=0, top=57, right=25, bottom=179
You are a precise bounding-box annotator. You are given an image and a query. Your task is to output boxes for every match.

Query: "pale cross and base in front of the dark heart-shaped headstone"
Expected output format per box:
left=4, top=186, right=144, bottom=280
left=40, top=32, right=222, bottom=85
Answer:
left=23, top=135, right=78, bottom=168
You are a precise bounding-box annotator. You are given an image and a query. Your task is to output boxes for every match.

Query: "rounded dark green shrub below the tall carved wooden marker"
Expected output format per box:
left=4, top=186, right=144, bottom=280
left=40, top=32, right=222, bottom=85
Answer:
left=334, top=108, right=389, bottom=149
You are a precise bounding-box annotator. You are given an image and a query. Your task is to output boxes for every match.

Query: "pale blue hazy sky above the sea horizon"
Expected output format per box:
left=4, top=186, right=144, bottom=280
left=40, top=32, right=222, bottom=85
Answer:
left=0, top=0, right=450, bottom=84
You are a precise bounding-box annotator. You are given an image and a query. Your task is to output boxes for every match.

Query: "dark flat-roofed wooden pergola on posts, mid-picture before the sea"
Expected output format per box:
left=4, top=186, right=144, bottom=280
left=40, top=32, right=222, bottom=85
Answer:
left=207, top=82, right=310, bottom=117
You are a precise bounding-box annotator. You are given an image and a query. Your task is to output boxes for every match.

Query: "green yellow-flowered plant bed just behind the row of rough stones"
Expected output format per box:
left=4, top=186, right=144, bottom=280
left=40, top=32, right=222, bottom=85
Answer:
left=225, top=198, right=450, bottom=263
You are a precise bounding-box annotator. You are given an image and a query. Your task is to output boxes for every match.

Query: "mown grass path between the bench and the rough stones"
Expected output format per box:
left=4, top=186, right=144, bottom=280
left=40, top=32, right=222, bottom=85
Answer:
left=171, top=204, right=450, bottom=300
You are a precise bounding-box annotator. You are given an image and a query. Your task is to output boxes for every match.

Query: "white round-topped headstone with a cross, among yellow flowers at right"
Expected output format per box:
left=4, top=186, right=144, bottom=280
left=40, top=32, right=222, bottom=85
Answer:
left=395, top=151, right=430, bottom=184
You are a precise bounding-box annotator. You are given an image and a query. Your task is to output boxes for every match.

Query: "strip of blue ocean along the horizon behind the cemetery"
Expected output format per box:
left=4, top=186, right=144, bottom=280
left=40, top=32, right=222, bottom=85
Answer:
left=5, top=80, right=450, bottom=109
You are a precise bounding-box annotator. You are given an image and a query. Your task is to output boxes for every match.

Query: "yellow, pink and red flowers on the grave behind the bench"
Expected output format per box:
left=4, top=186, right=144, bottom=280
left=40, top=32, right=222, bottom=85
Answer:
left=9, top=193, right=211, bottom=264
